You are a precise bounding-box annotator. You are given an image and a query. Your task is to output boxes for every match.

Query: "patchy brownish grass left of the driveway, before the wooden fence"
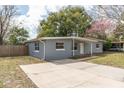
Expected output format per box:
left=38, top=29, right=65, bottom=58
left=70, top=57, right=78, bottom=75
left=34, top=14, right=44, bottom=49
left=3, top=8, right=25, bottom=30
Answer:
left=0, top=56, right=44, bottom=88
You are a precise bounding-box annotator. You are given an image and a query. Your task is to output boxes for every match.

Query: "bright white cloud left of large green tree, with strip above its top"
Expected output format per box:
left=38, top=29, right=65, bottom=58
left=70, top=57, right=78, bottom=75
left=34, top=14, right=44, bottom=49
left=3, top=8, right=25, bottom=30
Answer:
left=16, top=5, right=60, bottom=39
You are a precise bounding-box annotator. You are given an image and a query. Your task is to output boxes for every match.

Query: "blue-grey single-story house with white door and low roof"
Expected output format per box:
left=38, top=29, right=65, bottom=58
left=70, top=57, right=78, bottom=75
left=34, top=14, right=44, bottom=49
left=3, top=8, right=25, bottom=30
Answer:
left=26, top=37, right=103, bottom=60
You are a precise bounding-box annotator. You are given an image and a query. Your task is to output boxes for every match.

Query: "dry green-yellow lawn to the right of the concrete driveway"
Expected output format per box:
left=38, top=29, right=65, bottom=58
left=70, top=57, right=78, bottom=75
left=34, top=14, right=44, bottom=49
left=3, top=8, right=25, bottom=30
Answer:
left=82, top=52, right=124, bottom=68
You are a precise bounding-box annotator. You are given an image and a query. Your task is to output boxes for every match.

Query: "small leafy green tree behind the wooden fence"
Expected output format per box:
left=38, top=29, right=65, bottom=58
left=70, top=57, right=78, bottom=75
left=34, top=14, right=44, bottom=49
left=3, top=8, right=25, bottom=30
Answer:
left=8, top=26, right=29, bottom=45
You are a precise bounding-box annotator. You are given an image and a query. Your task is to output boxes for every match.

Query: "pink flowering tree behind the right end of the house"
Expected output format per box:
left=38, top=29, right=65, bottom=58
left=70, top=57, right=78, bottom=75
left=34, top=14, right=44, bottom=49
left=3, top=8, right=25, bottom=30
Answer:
left=86, top=19, right=115, bottom=39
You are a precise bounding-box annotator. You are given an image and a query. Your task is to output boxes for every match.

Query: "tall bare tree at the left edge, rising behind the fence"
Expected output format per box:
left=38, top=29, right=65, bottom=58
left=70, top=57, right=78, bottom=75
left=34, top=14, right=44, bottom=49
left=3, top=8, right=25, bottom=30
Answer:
left=0, top=5, right=17, bottom=45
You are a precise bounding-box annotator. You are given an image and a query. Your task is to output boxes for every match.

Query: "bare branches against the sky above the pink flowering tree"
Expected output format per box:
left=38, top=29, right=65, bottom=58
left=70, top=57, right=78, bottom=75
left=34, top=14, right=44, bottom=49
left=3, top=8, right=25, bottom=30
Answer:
left=90, top=5, right=124, bottom=22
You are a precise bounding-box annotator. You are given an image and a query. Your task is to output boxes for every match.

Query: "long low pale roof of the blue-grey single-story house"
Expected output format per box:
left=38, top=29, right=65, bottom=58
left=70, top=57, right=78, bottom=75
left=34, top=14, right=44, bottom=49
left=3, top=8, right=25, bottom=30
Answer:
left=26, top=37, right=104, bottom=43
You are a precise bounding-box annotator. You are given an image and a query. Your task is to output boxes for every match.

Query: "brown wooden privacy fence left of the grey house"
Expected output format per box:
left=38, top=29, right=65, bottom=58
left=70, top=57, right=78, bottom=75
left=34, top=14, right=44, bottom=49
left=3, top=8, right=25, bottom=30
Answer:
left=0, top=45, right=28, bottom=57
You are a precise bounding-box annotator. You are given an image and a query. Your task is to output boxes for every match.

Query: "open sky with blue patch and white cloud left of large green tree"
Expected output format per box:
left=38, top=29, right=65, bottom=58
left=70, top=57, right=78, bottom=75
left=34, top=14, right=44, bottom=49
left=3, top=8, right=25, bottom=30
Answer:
left=15, top=5, right=89, bottom=39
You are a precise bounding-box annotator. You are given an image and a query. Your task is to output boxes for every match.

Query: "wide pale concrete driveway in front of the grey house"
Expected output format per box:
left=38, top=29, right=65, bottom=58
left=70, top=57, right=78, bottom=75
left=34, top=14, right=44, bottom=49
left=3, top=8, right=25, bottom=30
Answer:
left=20, top=60, right=124, bottom=88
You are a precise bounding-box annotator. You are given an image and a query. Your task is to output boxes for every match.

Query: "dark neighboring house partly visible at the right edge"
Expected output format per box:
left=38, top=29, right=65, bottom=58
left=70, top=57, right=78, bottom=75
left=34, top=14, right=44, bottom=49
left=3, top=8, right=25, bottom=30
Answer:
left=110, top=41, right=124, bottom=51
